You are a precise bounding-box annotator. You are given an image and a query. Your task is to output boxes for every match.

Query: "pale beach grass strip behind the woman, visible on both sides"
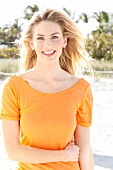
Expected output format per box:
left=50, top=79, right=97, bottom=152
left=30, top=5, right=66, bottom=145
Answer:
left=0, top=58, right=113, bottom=79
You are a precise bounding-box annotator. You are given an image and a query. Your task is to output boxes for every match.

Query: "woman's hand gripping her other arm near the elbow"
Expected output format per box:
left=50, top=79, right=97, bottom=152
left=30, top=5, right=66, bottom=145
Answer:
left=64, top=142, right=79, bottom=162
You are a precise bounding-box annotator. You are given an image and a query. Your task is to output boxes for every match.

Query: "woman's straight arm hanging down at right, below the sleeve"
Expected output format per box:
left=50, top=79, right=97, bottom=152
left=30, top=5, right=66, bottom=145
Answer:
left=74, top=125, right=94, bottom=170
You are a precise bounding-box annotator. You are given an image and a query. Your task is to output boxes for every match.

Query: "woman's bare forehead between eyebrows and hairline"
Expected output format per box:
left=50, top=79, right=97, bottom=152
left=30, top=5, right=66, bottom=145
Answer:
left=34, top=21, right=62, bottom=34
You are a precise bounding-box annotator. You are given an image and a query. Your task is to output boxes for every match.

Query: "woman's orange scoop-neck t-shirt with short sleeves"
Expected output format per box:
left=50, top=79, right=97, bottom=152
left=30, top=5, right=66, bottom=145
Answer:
left=0, top=75, right=93, bottom=170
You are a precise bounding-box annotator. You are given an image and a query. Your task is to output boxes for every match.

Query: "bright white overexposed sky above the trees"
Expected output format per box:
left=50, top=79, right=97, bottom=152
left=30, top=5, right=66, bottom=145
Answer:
left=0, top=0, right=113, bottom=34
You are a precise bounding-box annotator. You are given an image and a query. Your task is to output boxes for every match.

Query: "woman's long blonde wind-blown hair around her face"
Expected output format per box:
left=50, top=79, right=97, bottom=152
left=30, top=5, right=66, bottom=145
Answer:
left=20, top=9, right=90, bottom=75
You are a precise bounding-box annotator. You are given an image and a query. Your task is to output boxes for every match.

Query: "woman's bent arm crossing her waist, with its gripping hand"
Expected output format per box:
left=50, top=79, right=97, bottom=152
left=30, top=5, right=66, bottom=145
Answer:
left=2, top=118, right=79, bottom=164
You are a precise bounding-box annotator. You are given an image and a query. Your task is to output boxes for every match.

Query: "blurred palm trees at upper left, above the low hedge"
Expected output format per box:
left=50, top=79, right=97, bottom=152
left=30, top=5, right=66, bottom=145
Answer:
left=0, top=5, right=39, bottom=47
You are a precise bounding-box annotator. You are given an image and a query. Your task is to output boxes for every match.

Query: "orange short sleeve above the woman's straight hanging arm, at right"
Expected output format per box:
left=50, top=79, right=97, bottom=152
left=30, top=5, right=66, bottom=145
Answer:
left=76, top=84, right=93, bottom=127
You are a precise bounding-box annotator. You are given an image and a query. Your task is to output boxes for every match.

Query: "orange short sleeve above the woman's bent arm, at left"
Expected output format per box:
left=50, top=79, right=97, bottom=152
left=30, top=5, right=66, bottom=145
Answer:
left=0, top=77, right=20, bottom=120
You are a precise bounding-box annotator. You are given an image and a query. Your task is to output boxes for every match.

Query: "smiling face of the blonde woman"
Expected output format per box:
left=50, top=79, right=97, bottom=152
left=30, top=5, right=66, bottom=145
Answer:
left=31, top=21, right=67, bottom=61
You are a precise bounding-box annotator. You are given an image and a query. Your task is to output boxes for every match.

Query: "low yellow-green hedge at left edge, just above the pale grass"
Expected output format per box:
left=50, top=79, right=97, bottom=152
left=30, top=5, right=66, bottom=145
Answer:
left=0, top=47, right=19, bottom=58
